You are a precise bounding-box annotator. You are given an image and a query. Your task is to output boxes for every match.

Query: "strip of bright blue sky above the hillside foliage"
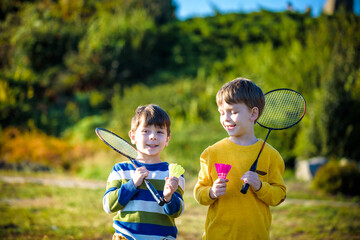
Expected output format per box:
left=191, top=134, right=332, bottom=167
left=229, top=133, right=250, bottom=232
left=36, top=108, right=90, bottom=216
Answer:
left=173, top=0, right=360, bottom=20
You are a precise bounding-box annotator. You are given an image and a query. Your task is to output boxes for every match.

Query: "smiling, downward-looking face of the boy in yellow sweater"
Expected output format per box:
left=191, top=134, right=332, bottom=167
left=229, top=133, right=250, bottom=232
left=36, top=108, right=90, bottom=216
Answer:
left=218, top=101, right=258, bottom=143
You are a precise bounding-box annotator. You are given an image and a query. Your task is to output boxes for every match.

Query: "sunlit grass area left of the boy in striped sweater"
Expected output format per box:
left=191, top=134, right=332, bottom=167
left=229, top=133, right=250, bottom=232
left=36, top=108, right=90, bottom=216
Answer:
left=0, top=180, right=112, bottom=239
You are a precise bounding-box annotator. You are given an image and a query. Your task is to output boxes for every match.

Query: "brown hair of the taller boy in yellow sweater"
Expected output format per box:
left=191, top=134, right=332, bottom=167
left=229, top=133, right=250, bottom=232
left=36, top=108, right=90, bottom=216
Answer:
left=216, top=78, right=265, bottom=118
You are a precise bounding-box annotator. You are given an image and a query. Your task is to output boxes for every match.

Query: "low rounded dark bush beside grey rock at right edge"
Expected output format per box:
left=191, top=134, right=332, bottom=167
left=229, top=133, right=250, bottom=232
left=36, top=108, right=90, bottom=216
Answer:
left=313, top=161, right=360, bottom=195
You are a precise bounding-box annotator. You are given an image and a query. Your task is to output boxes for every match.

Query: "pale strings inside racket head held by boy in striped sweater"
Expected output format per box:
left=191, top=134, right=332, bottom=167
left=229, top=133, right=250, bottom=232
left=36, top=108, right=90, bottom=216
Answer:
left=98, top=130, right=137, bottom=159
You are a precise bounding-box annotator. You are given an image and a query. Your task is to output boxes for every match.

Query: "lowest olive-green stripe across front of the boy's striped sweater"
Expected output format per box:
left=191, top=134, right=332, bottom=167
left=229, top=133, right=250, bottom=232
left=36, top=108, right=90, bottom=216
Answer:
left=114, top=211, right=175, bottom=227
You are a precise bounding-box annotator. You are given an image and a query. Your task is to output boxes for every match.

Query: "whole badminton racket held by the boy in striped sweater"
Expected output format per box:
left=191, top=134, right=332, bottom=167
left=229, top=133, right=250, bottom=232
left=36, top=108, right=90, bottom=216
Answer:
left=95, top=128, right=165, bottom=206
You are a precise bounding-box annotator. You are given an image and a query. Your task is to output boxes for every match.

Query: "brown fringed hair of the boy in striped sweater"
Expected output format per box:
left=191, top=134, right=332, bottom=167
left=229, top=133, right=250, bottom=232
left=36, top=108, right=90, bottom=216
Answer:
left=131, top=104, right=170, bottom=136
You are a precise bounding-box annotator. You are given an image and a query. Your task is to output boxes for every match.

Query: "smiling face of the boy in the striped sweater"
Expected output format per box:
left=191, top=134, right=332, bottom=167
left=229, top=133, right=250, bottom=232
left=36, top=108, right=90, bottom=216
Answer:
left=129, top=123, right=170, bottom=162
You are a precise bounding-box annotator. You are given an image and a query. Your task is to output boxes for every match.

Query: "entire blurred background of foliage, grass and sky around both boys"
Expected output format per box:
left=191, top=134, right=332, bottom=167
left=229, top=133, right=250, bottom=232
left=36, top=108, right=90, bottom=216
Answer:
left=0, top=0, right=360, bottom=239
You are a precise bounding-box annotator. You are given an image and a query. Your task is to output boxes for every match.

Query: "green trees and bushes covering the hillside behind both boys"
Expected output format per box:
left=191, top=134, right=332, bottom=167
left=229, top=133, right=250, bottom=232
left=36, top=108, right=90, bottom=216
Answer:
left=0, top=0, right=360, bottom=176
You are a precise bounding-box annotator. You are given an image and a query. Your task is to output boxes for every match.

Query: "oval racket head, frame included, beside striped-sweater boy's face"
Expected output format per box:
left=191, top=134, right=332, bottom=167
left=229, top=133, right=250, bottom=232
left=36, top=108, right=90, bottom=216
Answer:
left=95, top=128, right=138, bottom=159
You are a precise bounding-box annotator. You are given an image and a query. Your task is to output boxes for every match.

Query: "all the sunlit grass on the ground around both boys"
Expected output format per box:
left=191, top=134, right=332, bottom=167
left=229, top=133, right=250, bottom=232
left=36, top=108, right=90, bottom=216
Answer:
left=0, top=172, right=360, bottom=240
